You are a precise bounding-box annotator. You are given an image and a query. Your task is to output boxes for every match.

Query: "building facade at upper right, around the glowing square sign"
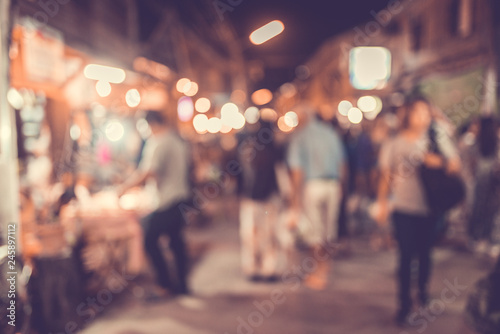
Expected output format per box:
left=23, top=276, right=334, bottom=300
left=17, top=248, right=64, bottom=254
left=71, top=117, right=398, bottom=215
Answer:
left=296, top=0, right=498, bottom=125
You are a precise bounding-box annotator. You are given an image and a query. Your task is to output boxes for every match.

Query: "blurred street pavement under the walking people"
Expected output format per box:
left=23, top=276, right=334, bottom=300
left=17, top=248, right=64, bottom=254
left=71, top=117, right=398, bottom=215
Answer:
left=83, top=205, right=488, bottom=334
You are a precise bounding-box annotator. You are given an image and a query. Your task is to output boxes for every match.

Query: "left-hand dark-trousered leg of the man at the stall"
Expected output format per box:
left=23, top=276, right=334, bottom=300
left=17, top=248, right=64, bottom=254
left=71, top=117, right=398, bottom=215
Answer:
left=144, top=211, right=172, bottom=289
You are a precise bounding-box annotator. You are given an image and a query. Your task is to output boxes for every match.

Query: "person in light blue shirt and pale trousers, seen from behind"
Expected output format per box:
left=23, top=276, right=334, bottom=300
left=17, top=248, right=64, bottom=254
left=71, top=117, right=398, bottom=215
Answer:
left=287, top=103, right=347, bottom=290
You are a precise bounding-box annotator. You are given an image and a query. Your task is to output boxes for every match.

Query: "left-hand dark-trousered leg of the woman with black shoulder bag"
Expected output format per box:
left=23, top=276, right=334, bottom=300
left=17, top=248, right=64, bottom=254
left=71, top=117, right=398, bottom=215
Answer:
left=392, top=212, right=415, bottom=321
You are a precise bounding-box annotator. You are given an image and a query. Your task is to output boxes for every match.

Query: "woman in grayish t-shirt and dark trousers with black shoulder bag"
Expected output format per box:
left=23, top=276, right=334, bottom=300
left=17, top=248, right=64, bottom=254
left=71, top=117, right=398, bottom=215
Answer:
left=377, top=98, right=460, bottom=325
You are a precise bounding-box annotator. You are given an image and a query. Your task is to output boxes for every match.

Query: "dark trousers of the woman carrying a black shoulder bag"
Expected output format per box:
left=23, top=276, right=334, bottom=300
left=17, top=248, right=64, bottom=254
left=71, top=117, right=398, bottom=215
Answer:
left=392, top=212, right=436, bottom=310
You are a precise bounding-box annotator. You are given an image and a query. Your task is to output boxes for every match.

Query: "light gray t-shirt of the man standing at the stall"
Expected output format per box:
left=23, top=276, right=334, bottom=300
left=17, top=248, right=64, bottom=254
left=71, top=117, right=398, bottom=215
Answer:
left=139, top=131, right=190, bottom=209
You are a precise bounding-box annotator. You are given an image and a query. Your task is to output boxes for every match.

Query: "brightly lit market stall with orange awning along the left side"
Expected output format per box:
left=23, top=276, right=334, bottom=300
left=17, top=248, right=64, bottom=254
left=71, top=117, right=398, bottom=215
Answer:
left=6, top=19, right=174, bottom=333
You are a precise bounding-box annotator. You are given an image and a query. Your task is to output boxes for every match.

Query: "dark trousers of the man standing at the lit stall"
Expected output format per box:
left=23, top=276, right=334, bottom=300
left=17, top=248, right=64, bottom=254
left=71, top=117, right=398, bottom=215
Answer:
left=143, top=202, right=188, bottom=293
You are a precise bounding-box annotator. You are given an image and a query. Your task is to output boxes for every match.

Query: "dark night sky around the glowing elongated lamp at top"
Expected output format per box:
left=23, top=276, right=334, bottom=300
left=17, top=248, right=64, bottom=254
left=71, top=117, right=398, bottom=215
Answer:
left=224, top=0, right=389, bottom=90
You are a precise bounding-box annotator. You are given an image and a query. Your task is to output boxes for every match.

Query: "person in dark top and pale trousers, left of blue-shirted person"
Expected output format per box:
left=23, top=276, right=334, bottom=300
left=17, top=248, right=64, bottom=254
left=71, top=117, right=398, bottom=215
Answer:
left=238, top=121, right=283, bottom=282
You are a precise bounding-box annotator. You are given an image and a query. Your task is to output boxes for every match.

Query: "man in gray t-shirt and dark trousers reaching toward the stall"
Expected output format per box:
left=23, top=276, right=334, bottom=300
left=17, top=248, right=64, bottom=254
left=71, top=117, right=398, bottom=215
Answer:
left=118, top=111, right=191, bottom=294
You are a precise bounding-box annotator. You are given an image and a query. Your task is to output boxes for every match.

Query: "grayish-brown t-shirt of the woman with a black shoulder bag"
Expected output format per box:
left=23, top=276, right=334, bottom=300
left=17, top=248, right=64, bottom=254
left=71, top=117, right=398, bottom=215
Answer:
left=379, top=129, right=457, bottom=215
